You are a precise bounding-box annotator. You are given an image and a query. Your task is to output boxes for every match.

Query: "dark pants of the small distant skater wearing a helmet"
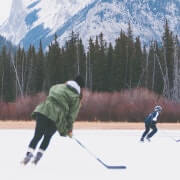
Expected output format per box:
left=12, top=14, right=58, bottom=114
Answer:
left=141, top=121, right=157, bottom=139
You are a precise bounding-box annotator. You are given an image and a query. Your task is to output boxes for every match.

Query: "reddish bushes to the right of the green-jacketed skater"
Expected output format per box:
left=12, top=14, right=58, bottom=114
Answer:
left=78, top=89, right=180, bottom=122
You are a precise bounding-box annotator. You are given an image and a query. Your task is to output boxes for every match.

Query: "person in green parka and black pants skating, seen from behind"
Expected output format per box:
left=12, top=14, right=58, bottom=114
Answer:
left=22, top=75, right=85, bottom=165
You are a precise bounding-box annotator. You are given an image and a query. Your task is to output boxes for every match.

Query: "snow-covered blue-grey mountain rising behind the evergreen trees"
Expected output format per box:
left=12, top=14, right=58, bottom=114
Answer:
left=0, top=0, right=180, bottom=49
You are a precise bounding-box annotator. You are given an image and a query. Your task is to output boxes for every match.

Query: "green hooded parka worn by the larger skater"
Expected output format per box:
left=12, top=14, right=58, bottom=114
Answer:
left=32, top=81, right=80, bottom=136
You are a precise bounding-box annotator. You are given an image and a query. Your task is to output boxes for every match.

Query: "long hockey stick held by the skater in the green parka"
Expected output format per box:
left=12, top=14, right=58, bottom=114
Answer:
left=72, top=137, right=126, bottom=169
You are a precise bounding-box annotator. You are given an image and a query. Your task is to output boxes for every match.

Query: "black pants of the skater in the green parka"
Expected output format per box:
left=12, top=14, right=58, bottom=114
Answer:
left=29, top=113, right=56, bottom=150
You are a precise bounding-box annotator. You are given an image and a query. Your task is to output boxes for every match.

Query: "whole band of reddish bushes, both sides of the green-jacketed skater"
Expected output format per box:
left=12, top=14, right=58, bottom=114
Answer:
left=0, top=89, right=180, bottom=122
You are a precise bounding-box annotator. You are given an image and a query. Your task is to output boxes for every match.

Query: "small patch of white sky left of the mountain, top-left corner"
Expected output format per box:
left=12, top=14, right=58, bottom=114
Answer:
left=0, top=0, right=11, bottom=25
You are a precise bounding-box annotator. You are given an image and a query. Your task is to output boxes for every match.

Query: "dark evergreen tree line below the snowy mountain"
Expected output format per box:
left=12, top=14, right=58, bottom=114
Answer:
left=0, top=21, right=180, bottom=102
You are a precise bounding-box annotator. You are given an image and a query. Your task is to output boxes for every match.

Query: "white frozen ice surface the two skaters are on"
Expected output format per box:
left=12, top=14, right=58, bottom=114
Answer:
left=0, top=129, right=180, bottom=180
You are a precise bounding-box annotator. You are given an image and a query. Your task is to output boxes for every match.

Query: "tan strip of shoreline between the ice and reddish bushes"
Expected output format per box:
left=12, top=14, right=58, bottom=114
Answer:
left=0, top=120, right=180, bottom=130
